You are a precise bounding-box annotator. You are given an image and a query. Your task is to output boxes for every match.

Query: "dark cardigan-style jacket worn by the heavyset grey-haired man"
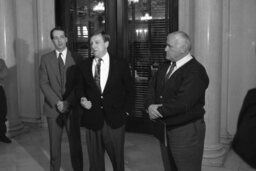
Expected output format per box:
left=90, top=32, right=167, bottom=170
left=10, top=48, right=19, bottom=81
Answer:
left=146, top=58, right=209, bottom=126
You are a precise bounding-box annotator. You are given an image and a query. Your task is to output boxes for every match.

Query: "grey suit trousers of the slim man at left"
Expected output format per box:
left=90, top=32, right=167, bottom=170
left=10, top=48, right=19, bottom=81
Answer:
left=47, top=109, right=83, bottom=171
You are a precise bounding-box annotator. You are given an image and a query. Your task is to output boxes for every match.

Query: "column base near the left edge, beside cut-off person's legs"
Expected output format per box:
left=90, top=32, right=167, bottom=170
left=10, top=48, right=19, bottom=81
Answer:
left=6, top=120, right=29, bottom=138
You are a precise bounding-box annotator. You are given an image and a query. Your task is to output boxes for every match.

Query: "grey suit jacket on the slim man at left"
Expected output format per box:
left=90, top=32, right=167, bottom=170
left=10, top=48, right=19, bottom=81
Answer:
left=39, top=51, right=78, bottom=117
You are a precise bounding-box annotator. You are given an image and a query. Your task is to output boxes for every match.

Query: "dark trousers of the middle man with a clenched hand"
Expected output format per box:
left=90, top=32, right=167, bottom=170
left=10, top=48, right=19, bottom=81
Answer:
left=86, top=123, right=125, bottom=171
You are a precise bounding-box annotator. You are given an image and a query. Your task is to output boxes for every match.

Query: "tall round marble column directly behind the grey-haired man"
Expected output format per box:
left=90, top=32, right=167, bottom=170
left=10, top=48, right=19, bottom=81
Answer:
left=194, top=0, right=226, bottom=166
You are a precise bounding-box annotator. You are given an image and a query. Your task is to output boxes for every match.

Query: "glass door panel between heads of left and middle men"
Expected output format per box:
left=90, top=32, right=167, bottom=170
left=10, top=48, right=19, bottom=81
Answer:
left=68, top=0, right=105, bottom=58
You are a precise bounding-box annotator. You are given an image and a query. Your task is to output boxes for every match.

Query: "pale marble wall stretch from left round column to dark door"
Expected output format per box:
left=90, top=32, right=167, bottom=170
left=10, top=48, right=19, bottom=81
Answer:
left=15, top=0, right=55, bottom=122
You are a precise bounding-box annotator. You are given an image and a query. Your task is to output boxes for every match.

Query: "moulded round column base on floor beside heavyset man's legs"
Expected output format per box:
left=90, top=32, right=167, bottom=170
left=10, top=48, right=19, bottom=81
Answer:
left=202, top=144, right=229, bottom=167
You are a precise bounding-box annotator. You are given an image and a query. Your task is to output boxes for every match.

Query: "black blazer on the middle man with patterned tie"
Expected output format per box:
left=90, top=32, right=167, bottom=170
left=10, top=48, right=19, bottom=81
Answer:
left=76, top=56, right=134, bottom=130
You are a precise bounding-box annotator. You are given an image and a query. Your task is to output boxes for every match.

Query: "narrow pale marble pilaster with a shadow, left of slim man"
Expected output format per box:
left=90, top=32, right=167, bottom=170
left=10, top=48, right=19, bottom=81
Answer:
left=15, top=0, right=41, bottom=123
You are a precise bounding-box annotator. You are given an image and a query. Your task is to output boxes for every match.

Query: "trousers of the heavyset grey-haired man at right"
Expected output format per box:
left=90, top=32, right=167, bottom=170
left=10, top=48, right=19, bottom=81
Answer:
left=160, top=119, right=205, bottom=171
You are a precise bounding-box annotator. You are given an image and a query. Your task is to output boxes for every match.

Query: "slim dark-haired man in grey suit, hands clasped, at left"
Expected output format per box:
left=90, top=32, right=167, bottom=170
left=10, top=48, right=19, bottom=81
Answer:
left=39, top=27, right=83, bottom=171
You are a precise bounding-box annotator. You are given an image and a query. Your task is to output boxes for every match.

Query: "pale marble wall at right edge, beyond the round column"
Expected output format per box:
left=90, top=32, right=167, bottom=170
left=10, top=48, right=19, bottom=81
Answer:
left=221, top=0, right=256, bottom=139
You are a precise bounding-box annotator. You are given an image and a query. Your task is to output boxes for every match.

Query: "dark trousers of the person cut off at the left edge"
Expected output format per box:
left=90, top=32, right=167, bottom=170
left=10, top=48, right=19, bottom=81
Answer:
left=0, top=85, right=7, bottom=136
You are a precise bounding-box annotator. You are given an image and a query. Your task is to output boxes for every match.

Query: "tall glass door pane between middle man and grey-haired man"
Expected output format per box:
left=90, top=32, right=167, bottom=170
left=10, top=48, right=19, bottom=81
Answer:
left=128, top=0, right=169, bottom=117
